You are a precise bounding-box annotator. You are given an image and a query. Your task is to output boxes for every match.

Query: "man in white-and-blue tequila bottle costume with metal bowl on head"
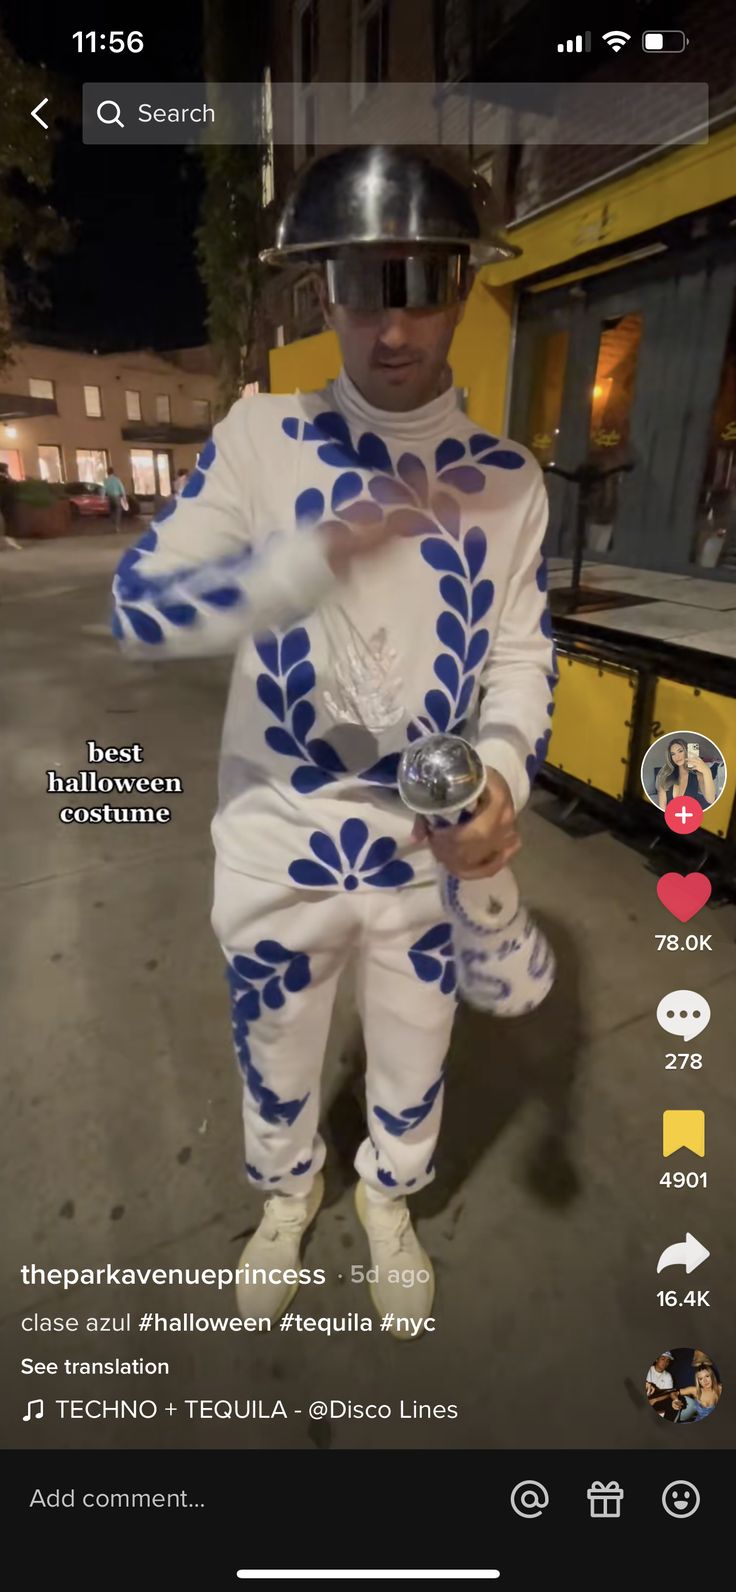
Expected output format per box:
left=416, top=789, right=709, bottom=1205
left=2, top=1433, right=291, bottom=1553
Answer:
left=113, top=146, right=556, bottom=1336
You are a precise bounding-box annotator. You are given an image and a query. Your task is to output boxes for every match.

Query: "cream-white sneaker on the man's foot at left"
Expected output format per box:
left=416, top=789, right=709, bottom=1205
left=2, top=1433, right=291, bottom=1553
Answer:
left=236, top=1172, right=325, bottom=1323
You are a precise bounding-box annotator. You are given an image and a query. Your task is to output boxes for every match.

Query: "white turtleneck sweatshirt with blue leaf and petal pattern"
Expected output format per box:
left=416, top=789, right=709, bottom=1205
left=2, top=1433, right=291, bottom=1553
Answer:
left=113, top=371, right=556, bottom=890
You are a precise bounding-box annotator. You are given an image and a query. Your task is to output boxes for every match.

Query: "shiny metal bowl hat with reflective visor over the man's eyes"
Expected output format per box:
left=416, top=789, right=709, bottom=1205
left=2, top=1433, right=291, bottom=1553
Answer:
left=260, top=145, right=519, bottom=309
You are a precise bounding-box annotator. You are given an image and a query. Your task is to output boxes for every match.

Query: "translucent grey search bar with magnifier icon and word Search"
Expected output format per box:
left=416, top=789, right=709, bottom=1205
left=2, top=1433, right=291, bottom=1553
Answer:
left=81, top=81, right=709, bottom=148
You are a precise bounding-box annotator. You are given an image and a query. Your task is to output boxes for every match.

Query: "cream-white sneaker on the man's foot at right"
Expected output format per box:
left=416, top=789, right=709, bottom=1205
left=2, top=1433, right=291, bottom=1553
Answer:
left=355, top=1180, right=435, bottom=1339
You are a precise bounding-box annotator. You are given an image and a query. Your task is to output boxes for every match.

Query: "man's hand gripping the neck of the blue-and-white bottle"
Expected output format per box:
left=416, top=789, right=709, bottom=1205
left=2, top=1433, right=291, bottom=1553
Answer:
left=413, top=769, right=521, bottom=879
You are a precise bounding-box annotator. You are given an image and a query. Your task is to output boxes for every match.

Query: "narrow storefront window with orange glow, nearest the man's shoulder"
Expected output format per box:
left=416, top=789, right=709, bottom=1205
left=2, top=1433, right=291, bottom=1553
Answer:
left=585, top=315, right=644, bottom=554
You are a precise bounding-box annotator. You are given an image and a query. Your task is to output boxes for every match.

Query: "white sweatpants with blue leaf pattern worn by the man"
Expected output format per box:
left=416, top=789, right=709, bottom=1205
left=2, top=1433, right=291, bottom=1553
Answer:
left=212, top=861, right=457, bottom=1197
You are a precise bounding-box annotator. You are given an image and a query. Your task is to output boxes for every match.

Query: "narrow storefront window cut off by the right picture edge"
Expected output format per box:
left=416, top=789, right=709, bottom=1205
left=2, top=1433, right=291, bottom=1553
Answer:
left=691, top=301, right=736, bottom=572
